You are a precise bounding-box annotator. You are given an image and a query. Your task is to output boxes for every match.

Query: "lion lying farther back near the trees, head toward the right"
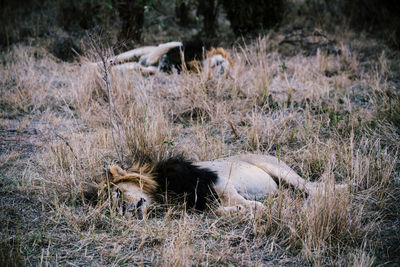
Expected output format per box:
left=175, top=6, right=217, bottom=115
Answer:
left=92, top=40, right=233, bottom=75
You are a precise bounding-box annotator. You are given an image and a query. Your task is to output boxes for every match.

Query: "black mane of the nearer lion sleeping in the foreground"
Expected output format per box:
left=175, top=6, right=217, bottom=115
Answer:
left=154, top=157, right=218, bottom=210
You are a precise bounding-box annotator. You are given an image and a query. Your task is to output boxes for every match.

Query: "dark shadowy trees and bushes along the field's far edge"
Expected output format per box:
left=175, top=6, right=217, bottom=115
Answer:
left=0, top=0, right=400, bottom=58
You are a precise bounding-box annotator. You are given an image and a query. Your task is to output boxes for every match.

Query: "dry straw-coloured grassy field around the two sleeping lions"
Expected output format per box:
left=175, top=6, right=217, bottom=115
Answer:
left=0, top=22, right=400, bottom=266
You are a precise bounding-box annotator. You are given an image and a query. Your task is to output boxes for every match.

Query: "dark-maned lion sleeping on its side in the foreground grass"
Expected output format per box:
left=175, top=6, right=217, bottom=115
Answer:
left=102, top=154, right=343, bottom=218
